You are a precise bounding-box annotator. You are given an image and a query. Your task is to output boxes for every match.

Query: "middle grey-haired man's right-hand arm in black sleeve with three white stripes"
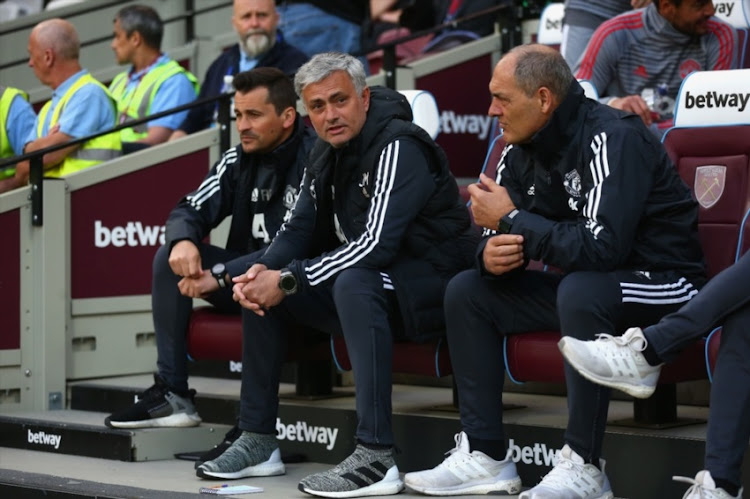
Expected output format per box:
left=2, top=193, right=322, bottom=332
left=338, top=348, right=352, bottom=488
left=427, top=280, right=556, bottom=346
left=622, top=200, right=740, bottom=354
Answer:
left=280, top=138, right=435, bottom=288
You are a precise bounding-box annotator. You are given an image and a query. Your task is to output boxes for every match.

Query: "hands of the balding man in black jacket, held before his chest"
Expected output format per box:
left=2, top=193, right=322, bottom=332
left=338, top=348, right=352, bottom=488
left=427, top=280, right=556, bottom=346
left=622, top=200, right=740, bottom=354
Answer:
left=468, top=173, right=524, bottom=275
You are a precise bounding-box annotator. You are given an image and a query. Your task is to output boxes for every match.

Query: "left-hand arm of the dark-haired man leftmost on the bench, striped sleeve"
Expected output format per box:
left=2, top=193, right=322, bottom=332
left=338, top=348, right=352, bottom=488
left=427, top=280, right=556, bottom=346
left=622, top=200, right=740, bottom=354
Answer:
left=165, top=147, right=240, bottom=248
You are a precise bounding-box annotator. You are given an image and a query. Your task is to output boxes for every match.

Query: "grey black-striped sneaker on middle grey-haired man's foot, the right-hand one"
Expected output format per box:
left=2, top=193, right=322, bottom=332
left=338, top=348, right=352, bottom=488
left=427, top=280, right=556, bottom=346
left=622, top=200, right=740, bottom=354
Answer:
left=297, top=444, right=404, bottom=497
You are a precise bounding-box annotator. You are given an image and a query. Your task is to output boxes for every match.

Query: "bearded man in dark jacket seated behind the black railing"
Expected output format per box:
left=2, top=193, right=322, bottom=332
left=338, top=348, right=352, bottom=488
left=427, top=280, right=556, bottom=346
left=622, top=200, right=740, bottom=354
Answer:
left=169, top=0, right=307, bottom=140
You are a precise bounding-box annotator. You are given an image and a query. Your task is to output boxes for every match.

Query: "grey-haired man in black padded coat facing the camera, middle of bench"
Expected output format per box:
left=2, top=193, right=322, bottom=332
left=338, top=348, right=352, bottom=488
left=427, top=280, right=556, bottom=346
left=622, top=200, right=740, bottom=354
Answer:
left=198, top=52, right=477, bottom=497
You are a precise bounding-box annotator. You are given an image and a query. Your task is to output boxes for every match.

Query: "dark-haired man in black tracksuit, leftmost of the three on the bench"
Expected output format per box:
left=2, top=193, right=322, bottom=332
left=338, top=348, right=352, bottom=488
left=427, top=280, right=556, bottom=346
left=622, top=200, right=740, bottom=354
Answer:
left=105, top=68, right=315, bottom=438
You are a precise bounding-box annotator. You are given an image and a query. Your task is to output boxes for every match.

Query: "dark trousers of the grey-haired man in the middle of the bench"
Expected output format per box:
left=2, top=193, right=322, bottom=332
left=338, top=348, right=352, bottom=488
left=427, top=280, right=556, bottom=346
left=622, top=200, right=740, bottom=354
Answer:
left=239, top=268, right=400, bottom=445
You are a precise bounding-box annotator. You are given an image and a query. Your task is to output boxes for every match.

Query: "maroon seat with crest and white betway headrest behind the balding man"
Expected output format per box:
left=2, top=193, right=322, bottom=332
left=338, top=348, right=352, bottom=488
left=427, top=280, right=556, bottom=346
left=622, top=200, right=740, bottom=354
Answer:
left=664, top=68, right=750, bottom=379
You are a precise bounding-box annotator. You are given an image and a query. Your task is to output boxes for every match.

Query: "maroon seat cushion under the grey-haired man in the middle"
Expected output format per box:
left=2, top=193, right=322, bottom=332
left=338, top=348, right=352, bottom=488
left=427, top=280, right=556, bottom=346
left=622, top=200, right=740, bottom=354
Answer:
left=331, top=335, right=453, bottom=377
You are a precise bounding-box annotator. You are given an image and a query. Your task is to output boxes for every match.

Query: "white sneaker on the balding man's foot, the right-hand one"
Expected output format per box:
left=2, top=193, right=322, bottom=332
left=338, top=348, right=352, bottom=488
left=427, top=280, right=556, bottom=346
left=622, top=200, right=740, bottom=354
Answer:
left=518, top=444, right=615, bottom=499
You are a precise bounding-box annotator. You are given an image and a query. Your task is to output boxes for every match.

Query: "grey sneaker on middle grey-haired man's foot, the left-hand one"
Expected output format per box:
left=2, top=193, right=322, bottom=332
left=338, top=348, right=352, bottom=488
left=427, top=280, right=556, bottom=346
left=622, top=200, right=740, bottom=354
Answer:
left=195, top=431, right=286, bottom=480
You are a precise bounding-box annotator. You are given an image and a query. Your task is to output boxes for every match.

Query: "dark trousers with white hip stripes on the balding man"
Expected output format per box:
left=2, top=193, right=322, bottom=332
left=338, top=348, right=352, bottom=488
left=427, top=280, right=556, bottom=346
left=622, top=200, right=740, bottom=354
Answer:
left=445, top=270, right=697, bottom=462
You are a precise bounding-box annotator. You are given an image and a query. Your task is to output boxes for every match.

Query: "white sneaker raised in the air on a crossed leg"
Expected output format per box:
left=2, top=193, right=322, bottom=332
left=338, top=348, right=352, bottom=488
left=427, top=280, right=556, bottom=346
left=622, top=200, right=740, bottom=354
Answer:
left=557, top=327, right=661, bottom=399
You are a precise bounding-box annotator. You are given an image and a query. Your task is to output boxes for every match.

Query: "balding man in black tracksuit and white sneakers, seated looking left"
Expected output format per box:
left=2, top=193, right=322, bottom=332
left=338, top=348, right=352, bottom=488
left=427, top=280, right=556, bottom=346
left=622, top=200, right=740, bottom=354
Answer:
left=405, top=45, right=705, bottom=499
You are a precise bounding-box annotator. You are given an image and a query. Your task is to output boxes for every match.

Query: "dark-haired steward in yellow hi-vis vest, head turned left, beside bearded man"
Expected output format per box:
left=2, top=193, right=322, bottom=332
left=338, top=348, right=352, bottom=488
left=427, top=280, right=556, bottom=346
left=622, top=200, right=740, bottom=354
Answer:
left=109, top=5, right=198, bottom=150
